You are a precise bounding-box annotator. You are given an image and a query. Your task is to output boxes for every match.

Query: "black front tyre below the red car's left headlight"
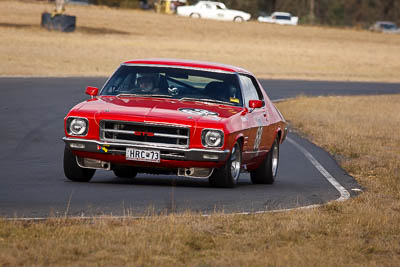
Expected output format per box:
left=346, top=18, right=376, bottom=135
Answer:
left=64, top=147, right=96, bottom=182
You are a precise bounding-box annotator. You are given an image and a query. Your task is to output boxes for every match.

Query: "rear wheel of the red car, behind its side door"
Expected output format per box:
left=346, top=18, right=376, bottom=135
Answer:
left=250, top=137, right=279, bottom=184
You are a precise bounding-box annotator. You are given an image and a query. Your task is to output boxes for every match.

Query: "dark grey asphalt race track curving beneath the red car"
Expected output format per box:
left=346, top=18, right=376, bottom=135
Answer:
left=0, top=78, right=400, bottom=218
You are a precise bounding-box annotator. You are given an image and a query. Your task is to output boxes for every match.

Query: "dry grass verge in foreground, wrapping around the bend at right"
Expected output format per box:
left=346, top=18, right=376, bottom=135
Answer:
left=0, top=95, right=400, bottom=266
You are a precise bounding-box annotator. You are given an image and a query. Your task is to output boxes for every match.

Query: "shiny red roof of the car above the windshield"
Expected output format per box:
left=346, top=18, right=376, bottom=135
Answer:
left=123, top=58, right=252, bottom=75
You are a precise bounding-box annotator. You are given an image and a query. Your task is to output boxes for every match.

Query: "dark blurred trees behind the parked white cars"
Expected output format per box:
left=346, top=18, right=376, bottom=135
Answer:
left=90, top=0, right=400, bottom=27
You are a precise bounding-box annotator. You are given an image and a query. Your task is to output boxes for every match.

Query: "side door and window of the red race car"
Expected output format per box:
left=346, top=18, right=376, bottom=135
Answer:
left=239, top=74, right=269, bottom=164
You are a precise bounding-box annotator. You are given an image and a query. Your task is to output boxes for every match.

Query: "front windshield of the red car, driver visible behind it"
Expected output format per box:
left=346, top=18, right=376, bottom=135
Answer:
left=100, top=65, right=243, bottom=106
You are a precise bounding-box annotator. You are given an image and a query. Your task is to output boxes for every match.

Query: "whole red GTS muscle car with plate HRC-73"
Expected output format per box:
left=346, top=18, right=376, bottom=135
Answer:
left=63, top=59, right=287, bottom=187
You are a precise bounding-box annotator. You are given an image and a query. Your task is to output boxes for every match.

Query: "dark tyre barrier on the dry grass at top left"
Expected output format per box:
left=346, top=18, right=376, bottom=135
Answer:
left=40, top=13, right=76, bottom=32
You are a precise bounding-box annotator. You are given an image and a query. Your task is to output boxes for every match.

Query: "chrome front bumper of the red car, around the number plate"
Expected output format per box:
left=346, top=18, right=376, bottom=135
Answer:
left=63, top=137, right=231, bottom=162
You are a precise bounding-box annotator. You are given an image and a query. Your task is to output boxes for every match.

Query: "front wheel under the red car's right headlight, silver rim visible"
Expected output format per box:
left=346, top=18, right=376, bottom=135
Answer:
left=209, top=142, right=242, bottom=188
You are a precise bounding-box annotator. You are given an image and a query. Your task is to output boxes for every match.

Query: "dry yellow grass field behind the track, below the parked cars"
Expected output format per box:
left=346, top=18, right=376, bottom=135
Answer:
left=0, top=1, right=400, bottom=82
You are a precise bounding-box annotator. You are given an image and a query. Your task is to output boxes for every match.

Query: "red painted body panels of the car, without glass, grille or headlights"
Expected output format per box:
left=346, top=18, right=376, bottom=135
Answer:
left=64, top=59, right=286, bottom=170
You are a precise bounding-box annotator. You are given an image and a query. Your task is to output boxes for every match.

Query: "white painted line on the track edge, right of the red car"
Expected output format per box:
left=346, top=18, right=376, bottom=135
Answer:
left=286, top=137, right=350, bottom=201
